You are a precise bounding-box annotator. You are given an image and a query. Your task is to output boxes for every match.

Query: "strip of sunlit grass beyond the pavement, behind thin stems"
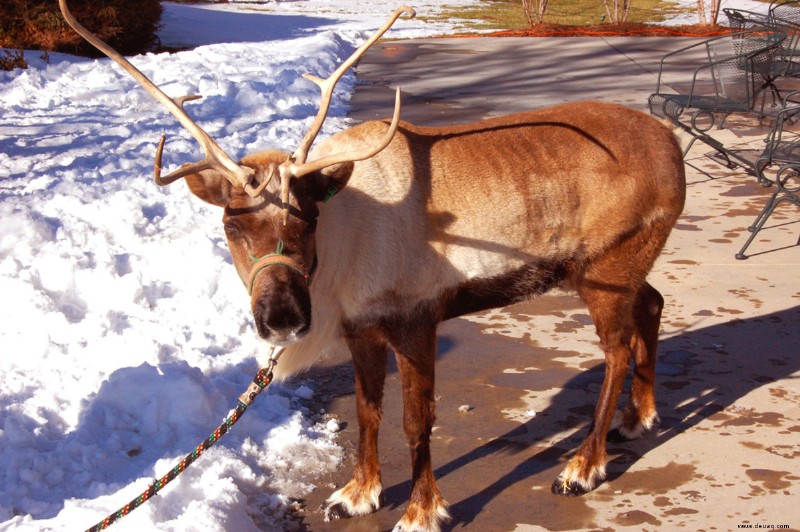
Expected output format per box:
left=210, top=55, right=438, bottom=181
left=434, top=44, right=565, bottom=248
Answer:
left=428, top=0, right=685, bottom=30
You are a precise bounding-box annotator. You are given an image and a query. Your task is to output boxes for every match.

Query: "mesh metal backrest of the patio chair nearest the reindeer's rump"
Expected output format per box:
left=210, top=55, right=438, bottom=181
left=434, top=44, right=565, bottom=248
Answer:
left=706, top=27, right=786, bottom=109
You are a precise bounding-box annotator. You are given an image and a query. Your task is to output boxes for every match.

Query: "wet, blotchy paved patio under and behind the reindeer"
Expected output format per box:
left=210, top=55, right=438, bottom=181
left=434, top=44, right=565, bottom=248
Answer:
left=301, top=37, right=800, bottom=531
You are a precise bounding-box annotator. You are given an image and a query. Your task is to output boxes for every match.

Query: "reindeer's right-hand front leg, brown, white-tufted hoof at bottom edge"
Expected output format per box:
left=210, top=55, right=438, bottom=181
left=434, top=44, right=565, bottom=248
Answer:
left=392, top=325, right=450, bottom=532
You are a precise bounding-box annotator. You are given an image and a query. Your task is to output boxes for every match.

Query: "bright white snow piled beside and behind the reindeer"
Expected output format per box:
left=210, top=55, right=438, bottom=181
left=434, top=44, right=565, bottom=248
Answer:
left=0, top=0, right=768, bottom=531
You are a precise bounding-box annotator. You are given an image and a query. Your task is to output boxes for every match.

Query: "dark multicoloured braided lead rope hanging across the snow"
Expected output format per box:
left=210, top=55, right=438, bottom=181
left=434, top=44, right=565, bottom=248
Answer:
left=86, top=347, right=283, bottom=532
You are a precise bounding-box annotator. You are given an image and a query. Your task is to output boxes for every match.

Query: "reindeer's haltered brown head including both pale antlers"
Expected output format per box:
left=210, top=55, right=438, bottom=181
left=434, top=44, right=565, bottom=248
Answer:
left=59, top=0, right=415, bottom=345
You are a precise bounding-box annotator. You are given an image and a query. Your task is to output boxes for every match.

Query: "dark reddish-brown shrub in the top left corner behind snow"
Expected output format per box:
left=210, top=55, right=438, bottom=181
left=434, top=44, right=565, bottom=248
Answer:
left=0, top=0, right=162, bottom=57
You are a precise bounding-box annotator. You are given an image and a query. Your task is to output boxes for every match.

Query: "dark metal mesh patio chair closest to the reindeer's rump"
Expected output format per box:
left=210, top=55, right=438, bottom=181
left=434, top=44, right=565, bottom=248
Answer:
left=648, top=27, right=786, bottom=167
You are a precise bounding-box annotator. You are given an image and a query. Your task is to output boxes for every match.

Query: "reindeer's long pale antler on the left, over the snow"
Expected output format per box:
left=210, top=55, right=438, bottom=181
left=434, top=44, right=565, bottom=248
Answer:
left=58, top=0, right=255, bottom=195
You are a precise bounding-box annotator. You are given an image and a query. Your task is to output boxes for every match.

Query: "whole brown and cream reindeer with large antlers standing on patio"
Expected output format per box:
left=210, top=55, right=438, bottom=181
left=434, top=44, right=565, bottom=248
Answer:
left=59, top=0, right=685, bottom=531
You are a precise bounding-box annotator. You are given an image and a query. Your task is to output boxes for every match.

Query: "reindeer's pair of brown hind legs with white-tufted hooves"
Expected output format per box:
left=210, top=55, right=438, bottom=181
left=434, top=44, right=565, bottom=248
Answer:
left=552, top=219, right=671, bottom=495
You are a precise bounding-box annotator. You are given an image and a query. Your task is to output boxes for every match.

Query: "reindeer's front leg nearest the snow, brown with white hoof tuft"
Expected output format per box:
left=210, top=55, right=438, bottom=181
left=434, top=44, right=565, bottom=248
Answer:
left=324, top=334, right=387, bottom=521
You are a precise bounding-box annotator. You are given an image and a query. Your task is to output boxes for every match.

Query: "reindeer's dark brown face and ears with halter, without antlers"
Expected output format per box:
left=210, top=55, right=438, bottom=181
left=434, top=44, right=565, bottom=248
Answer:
left=186, top=151, right=360, bottom=345
